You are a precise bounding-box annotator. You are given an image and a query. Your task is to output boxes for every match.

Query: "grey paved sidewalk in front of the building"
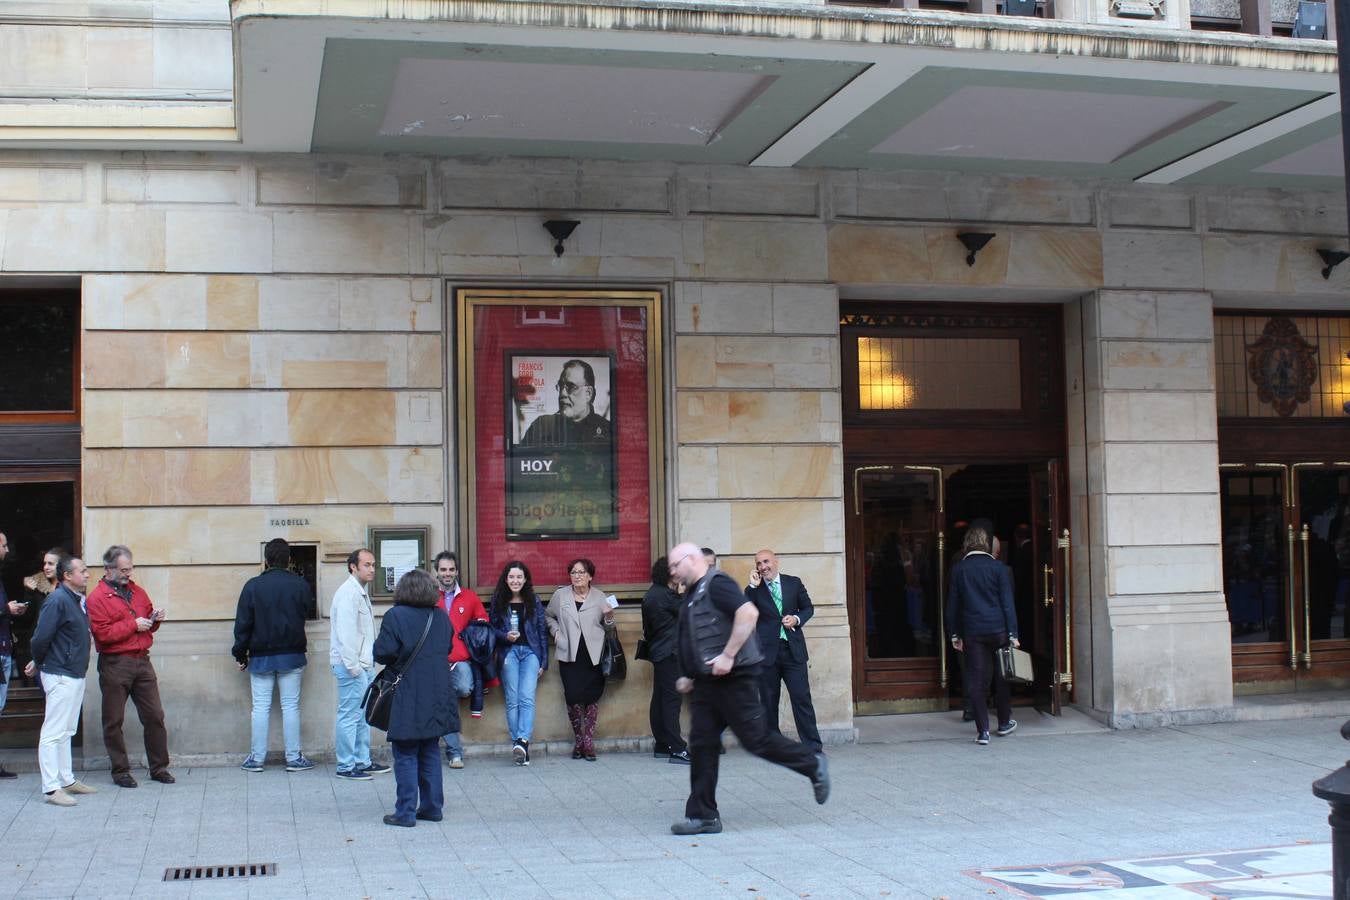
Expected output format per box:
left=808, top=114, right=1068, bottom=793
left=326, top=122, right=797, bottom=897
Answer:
left=0, top=710, right=1350, bottom=900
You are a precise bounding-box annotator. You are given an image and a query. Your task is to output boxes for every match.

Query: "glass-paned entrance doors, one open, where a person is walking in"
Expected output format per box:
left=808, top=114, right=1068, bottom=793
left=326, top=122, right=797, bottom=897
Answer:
left=846, top=461, right=1071, bottom=715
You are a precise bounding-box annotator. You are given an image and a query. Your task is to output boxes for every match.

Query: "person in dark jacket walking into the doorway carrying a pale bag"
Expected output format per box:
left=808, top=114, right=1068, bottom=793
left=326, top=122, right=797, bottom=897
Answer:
left=946, top=524, right=1021, bottom=746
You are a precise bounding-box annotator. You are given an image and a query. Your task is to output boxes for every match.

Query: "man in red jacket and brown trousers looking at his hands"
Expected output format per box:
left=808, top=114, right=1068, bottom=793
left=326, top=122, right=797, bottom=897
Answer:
left=86, top=544, right=174, bottom=788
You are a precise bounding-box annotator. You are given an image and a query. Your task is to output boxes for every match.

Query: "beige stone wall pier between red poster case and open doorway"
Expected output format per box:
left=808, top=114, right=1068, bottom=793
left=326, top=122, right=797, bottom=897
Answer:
left=674, top=282, right=853, bottom=742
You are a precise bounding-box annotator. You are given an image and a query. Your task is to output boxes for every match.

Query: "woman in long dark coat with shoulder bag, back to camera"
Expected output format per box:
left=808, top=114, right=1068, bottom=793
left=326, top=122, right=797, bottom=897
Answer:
left=375, top=569, right=459, bottom=828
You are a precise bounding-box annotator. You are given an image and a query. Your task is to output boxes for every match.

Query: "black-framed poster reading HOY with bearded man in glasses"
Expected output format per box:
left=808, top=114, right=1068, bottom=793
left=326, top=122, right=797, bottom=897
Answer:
left=505, top=351, right=618, bottom=540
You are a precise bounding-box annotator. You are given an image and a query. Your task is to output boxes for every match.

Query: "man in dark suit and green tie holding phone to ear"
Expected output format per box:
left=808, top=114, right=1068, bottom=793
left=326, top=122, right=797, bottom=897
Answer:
left=745, top=549, right=824, bottom=753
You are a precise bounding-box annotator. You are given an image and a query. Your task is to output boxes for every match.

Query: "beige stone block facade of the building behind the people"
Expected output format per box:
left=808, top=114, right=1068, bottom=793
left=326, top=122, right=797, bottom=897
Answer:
left=0, top=4, right=1350, bottom=757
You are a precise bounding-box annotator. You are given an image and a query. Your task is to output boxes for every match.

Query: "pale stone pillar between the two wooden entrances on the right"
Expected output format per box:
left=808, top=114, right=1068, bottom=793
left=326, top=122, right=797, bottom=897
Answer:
left=1071, top=290, right=1233, bottom=726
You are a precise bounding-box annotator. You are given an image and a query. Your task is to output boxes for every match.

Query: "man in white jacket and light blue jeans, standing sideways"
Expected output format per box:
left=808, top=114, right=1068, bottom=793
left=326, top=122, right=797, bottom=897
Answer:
left=328, top=548, right=390, bottom=781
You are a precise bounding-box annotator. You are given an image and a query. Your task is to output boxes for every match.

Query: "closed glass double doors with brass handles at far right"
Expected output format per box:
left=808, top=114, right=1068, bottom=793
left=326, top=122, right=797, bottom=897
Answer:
left=1219, top=461, right=1350, bottom=694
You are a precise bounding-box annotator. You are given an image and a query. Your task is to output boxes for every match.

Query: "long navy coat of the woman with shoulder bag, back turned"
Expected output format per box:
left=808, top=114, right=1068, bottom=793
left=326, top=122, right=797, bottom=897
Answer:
left=375, top=606, right=459, bottom=741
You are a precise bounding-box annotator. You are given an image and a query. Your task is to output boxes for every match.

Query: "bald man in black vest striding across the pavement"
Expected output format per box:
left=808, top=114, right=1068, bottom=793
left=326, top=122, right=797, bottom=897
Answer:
left=667, top=544, right=830, bottom=834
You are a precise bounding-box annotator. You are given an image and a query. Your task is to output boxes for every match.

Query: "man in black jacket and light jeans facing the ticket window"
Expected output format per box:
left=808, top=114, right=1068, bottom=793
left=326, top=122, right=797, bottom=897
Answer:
left=232, top=537, right=315, bottom=772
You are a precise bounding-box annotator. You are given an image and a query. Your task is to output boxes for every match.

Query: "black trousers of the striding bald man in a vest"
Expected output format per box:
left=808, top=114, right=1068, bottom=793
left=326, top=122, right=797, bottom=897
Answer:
left=684, top=672, right=817, bottom=819
